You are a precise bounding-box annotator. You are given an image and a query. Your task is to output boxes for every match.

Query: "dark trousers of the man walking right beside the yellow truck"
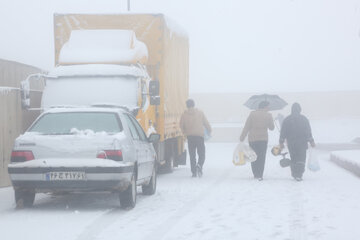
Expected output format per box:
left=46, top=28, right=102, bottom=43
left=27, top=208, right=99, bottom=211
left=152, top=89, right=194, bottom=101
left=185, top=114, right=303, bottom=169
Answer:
left=187, top=136, right=205, bottom=174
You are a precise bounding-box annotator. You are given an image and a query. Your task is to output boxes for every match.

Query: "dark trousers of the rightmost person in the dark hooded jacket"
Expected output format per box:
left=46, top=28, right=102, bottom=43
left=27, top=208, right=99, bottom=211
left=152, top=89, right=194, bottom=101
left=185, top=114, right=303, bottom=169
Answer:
left=289, top=147, right=306, bottom=178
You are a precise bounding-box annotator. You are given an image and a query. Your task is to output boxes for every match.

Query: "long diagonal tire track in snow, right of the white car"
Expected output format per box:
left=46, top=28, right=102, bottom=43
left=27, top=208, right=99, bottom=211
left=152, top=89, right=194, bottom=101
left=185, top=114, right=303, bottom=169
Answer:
left=143, top=168, right=232, bottom=240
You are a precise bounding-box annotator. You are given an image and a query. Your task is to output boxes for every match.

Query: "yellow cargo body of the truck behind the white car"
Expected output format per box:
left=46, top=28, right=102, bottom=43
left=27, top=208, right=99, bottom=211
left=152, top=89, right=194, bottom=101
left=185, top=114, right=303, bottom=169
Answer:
left=54, top=14, right=189, bottom=168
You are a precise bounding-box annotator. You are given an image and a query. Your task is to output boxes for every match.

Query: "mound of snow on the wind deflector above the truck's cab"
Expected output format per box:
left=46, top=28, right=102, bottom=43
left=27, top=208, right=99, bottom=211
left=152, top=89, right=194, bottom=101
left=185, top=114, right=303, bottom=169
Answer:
left=59, top=29, right=148, bottom=65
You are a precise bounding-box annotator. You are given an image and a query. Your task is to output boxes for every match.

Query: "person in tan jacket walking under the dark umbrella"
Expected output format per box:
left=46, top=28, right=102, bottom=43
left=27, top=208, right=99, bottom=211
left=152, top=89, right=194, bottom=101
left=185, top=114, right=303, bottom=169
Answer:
left=240, top=101, right=275, bottom=181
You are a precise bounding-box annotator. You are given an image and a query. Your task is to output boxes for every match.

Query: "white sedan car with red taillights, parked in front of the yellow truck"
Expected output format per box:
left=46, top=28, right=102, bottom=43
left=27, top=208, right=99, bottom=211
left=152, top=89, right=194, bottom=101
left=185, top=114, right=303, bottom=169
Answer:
left=8, top=107, right=160, bottom=208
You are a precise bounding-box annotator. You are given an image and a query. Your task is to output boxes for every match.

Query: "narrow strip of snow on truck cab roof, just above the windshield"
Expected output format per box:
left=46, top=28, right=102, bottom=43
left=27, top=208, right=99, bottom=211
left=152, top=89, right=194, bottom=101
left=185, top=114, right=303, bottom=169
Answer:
left=48, top=64, right=146, bottom=77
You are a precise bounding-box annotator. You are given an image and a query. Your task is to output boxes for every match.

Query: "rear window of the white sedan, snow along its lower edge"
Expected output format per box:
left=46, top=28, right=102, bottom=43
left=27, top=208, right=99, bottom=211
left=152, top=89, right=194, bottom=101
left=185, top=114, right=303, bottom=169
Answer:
left=29, top=112, right=122, bottom=135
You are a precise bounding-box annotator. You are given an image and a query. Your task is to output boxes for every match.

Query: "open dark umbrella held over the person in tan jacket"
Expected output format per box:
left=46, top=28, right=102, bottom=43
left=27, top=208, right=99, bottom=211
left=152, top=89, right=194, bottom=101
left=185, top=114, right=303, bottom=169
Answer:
left=244, top=94, right=287, bottom=110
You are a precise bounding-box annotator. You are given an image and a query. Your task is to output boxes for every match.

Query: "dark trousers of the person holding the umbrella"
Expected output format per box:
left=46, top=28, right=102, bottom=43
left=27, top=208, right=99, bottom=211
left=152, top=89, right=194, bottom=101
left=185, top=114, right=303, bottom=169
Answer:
left=249, top=141, right=267, bottom=178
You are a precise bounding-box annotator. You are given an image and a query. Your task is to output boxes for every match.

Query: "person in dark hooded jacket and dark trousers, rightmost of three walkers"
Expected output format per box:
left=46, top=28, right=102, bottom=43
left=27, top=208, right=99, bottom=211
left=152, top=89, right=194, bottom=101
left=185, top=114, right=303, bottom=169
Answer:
left=279, top=103, right=315, bottom=181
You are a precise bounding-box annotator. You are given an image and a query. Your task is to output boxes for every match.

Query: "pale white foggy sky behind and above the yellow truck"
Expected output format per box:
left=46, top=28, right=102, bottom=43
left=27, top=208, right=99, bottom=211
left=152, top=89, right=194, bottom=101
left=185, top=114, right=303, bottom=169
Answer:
left=0, top=0, right=360, bottom=93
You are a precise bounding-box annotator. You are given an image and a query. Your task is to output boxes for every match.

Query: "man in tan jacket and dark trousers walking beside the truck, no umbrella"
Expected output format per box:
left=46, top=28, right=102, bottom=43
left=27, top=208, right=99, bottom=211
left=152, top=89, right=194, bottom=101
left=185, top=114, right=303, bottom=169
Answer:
left=180, top=99, right=211, bottom=177
